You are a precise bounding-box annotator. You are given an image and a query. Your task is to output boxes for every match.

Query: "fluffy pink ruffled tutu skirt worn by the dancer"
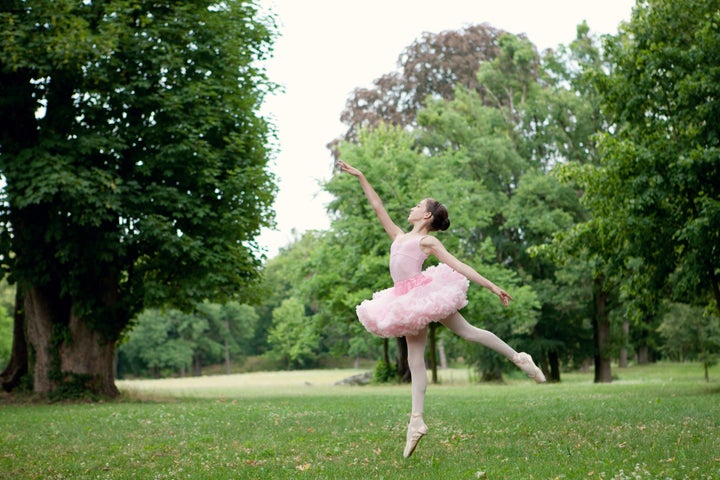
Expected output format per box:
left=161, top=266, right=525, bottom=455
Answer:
left=356, top=263, right=470, bottom=337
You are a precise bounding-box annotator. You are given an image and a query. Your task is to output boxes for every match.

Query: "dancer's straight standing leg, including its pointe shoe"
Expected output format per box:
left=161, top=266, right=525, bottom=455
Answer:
left=403, top=327, right=428, bottom=458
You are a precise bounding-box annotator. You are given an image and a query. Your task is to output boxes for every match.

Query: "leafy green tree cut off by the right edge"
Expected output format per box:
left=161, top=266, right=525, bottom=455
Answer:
left=586, top=0, right=720, bottom=376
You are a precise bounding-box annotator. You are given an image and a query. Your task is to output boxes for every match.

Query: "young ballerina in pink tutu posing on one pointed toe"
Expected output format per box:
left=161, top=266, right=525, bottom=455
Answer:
left=338, top=161, right=545, bottom=458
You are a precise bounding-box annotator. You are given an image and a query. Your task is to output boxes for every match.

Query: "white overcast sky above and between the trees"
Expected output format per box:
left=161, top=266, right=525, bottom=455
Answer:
left=258, top=0, right=635, bottom=257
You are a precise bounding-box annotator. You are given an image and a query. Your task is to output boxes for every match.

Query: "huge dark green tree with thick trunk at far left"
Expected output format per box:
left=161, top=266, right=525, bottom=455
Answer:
left=0, top=0, right=275, bottom=396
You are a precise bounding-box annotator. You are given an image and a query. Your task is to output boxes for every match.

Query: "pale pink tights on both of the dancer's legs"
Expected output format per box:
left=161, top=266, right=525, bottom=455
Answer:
left=405, top=312, right=517, bottom=414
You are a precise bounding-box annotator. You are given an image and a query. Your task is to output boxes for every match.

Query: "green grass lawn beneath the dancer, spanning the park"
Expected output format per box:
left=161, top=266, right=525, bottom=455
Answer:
left=0, top=364, right=720, bottom=480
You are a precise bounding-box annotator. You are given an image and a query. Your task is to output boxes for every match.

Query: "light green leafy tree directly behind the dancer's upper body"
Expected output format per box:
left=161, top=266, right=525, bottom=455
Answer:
left=327, top=124, right=538, bottom=378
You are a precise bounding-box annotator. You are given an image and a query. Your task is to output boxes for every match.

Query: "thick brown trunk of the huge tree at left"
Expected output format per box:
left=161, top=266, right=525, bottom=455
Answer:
left=25, top=287, right=119, bottom=397
